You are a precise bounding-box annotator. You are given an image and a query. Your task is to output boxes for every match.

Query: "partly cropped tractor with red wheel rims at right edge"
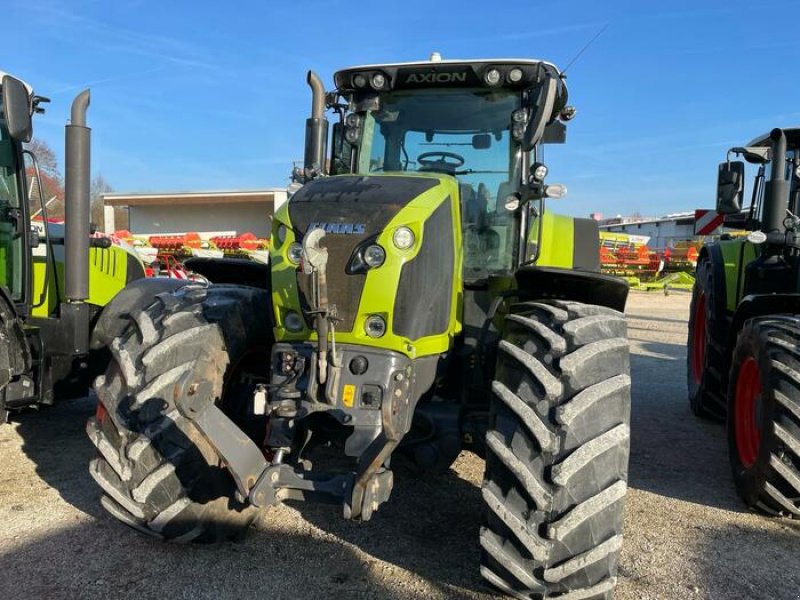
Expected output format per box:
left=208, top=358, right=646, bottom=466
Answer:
left=687, top=129, right=800, bottom=518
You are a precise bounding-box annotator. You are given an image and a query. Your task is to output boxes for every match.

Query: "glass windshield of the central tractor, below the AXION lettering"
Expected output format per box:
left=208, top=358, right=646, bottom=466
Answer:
left=356, top=88, right=521, bottom=280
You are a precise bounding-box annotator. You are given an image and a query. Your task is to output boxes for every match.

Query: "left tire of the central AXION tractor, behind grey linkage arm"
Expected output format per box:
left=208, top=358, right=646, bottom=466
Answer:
left=87, top=286, right=272, bottom=542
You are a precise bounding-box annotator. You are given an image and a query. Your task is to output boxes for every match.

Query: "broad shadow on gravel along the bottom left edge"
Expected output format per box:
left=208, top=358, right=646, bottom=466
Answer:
left=0, top=519, right=492, bottom=600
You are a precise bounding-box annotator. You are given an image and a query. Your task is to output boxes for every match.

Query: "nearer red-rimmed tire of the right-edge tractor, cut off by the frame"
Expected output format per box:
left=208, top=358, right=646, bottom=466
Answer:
left=728, top=315, right=800, bottom=519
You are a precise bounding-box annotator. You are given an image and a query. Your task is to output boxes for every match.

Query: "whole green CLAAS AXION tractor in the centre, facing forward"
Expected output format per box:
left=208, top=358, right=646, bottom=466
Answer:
left=88, top=56, right=630, bottom=598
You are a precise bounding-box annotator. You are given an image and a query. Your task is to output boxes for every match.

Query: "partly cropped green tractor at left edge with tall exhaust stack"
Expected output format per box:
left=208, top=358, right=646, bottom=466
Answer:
left=0, top=73, right=152, bottom=424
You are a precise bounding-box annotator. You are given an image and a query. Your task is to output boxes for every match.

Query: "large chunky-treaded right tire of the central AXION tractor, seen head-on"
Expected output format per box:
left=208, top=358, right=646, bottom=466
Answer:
left=480, top=301, right=630, bottom=598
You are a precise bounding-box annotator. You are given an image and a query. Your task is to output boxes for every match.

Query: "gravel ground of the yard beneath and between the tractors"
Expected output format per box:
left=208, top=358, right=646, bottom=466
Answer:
left=0, top=294, right=800, bottom=600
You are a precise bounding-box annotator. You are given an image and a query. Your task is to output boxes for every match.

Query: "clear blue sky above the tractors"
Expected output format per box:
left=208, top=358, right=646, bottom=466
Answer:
left=6, top=0, right=800, bottom=216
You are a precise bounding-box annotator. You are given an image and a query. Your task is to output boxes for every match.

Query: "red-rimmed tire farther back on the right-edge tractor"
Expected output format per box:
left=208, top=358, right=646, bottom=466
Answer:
left=686, top=257, right=725, bottom=421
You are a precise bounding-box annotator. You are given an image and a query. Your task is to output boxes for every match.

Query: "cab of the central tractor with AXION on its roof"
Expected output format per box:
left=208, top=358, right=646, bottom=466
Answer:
left=304, top=54, right=574, bottom=281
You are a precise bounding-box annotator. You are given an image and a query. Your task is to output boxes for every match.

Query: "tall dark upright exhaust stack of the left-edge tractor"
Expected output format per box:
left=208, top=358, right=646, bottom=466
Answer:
left=61, top=90, right=91, bottom=354
